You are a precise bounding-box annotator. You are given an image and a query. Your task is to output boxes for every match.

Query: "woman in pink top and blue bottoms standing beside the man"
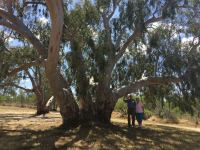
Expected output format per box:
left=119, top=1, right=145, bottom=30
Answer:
left=136, top=98, right=144, bottom=128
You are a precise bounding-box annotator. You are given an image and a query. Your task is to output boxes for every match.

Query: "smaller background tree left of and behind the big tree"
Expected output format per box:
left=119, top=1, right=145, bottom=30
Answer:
left=0, top=36, right=47, bottom=115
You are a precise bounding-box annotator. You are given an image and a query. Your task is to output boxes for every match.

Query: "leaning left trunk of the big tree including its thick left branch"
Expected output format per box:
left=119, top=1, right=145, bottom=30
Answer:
left=0, top=0, right=79, bottom=125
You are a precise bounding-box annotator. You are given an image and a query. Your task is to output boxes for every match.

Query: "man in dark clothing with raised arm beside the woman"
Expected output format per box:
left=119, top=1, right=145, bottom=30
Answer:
left=124, top=95, right=136, bottom=127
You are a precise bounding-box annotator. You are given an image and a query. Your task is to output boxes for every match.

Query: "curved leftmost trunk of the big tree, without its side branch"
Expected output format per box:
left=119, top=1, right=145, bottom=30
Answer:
left=45, top=0, right=79, bottom=126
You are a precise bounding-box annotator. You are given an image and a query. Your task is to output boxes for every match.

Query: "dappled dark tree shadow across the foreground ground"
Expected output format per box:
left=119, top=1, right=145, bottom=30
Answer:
left=0, top=115, right=200, bottom=150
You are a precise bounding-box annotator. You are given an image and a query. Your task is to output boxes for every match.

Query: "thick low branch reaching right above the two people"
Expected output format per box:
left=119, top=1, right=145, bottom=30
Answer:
left=114, top=77, right=181, bottom=99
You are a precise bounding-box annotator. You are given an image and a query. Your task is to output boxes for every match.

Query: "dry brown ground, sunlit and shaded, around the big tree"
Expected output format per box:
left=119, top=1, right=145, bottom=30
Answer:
left=0, top=106, right=200, bottom=150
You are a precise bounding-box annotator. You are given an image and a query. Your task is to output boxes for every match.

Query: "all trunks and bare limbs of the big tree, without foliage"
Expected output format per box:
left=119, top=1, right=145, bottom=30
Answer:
left=0, top=0, right=198, bottom=126
